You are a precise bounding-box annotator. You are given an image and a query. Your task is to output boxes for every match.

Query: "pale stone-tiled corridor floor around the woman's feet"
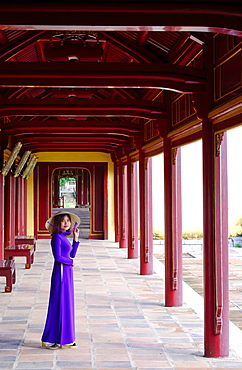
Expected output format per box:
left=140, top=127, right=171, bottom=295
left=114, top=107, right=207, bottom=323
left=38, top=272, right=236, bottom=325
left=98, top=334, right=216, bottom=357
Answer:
left=0, top=240, right=242, bottom=370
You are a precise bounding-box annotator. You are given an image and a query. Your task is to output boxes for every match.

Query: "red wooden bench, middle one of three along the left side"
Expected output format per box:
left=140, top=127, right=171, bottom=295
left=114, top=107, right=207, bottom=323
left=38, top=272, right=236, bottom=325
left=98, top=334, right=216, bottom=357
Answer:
left=4, top=244, right=35, bottom=269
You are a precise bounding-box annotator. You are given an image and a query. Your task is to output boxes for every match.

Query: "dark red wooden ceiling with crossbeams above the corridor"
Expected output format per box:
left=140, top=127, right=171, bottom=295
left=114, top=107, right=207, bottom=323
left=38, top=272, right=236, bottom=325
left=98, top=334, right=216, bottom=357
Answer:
left=0, top=1, right=242, bottom=153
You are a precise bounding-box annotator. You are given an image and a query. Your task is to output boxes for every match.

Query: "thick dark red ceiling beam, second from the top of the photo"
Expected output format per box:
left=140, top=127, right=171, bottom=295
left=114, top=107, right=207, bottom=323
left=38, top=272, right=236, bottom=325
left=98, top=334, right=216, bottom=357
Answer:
left=0, top=62, right=206, bottom=93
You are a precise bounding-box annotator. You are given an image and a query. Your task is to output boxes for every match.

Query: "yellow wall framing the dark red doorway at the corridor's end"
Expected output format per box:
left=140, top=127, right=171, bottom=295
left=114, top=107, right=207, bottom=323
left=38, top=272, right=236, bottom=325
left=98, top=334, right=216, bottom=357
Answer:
left=27, top=152, right=115, bottom=240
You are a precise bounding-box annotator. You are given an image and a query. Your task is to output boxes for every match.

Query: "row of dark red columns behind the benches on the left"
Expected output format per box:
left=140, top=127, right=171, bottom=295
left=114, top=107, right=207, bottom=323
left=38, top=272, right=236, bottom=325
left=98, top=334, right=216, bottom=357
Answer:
left=0, top=173, right=27, bottom=259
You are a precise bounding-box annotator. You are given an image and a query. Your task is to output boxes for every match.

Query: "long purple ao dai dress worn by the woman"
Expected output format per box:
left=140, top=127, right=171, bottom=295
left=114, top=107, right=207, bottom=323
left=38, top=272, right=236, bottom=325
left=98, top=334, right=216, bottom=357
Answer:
left=42, top=234, right=79, bottom=344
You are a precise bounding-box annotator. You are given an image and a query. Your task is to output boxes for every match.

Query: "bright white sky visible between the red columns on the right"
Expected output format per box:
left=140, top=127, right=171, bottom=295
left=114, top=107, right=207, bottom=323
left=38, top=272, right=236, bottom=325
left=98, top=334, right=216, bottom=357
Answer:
left=152, top=126, right=242, bottom=235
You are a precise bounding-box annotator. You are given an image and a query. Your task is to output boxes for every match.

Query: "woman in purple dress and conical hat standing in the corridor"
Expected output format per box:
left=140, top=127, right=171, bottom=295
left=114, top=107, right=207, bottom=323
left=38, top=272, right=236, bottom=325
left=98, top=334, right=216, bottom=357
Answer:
left=42, top=212, right=80, bottom=349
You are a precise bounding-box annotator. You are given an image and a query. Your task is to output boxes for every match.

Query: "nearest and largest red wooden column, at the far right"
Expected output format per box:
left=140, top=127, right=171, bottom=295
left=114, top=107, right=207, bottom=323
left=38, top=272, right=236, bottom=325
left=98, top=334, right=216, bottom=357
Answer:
left=203, top=117, right=229, bottom=357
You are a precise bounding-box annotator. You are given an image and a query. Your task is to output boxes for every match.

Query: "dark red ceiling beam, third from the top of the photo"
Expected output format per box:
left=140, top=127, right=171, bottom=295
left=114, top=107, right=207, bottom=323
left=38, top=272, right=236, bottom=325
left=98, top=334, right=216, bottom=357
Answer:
left=0, top=99, right=166, bottom=119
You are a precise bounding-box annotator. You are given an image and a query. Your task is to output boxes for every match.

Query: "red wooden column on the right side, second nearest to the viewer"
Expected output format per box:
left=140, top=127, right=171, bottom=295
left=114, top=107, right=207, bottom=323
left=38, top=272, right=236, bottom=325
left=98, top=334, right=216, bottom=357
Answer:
left=164, top=138, right=182, bottom=307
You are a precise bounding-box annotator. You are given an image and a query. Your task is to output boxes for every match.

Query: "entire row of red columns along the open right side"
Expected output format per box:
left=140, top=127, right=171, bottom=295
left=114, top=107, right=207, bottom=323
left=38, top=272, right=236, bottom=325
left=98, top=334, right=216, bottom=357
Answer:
left=114, top=125, right=229, bottom=357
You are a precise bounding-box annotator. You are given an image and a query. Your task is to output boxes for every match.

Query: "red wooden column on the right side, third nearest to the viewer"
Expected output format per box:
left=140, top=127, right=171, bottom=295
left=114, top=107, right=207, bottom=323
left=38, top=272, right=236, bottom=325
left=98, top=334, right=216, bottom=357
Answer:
left=139, top=149, right=153, bottom=275
